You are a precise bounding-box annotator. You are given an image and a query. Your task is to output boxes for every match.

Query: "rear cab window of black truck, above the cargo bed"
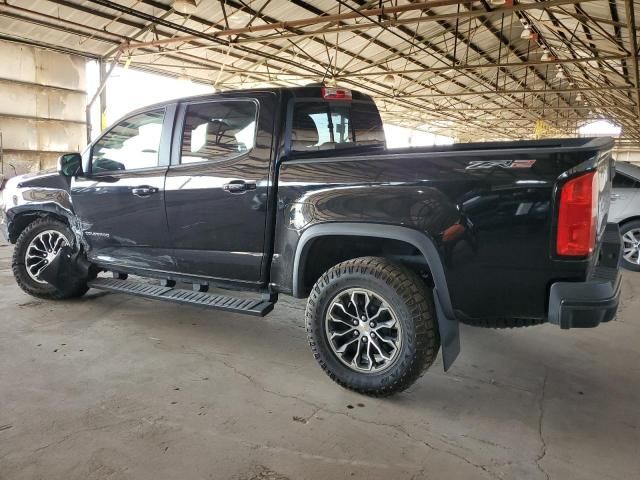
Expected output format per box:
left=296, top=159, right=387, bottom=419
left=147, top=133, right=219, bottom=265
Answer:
left=291, top=101, right=385, bottom=152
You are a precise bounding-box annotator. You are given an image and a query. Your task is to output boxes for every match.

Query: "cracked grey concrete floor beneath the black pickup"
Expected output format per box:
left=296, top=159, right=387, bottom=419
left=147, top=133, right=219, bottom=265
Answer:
left=0, top=240, right=640, bottom=480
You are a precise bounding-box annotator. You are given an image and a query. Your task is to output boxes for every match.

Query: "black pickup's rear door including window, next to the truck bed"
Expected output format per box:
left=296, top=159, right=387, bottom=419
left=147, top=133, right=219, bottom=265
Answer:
left=165, top=93, right=278, bottom=284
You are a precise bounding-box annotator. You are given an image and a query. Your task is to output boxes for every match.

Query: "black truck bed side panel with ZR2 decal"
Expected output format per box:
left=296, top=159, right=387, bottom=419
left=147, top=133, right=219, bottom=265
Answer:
left=272, top=142, right=612, bottom=318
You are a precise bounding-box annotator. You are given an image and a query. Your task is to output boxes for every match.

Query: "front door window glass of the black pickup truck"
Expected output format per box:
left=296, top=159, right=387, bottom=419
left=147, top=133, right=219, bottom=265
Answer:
left=91, top=109, right=164, bottom=173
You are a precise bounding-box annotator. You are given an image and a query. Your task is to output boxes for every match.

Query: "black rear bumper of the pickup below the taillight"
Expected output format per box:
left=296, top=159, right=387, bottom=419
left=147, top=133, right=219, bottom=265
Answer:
left=548, top=223, right=622, bottom=329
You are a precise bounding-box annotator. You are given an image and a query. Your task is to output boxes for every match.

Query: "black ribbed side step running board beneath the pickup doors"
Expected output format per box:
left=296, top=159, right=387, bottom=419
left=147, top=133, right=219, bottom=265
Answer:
left=89, top=278, right=273, bottom=317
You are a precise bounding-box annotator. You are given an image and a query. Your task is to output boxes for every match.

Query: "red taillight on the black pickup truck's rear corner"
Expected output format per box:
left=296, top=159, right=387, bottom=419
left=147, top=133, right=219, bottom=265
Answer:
left=556, top=172, right=598, bottom=257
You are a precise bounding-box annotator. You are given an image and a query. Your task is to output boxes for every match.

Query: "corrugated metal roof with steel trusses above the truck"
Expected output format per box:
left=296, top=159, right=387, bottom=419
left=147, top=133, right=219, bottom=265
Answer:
left=0, top=0, right=640, bottom=142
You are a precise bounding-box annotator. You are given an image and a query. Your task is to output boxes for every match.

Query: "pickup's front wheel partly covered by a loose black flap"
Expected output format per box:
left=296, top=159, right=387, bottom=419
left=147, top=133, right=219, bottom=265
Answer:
left=11, top=217, right=88, bottom=300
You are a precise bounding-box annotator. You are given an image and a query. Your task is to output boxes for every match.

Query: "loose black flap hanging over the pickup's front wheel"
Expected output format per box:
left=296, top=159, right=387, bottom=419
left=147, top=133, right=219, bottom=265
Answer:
left=39, top=247, right=91, bottom=293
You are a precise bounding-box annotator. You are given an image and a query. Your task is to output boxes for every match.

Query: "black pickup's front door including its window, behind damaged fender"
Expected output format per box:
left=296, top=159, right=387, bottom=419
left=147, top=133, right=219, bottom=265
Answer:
left=71, top=106, right=175, bottom=270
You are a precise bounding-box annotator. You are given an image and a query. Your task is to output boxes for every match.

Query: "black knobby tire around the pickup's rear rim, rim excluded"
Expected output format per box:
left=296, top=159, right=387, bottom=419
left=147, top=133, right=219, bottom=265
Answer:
left=305, top=257, right=440, bottom=397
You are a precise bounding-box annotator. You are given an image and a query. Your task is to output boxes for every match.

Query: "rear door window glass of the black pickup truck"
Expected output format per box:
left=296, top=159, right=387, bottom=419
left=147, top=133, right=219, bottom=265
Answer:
left=180, top=101, right=257, bottom=163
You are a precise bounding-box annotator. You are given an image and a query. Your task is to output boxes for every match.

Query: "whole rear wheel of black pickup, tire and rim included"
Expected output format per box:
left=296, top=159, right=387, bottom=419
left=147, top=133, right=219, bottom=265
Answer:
left=306, top=257, right=440, bottom=397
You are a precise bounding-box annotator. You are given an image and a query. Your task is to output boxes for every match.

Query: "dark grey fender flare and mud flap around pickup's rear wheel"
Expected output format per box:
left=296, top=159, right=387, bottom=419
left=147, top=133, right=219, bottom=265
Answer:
left=293, top=222, right=460, bottom=371
